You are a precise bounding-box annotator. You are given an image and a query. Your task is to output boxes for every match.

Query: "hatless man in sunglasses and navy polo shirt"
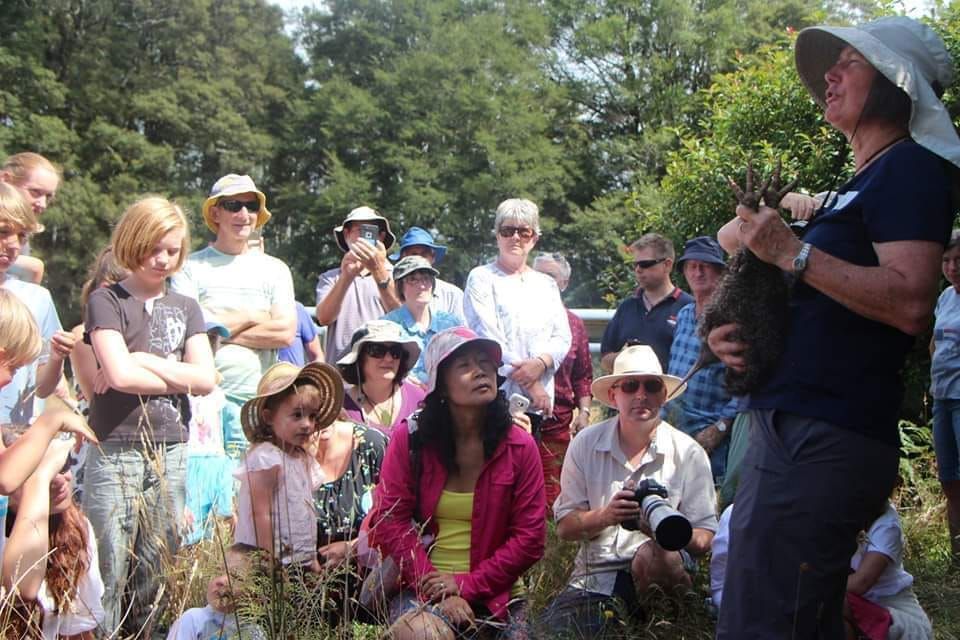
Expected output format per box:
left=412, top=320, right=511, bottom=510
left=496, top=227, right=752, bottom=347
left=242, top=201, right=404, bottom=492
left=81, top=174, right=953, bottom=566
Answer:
left=600, top=233, right=693, bottom=373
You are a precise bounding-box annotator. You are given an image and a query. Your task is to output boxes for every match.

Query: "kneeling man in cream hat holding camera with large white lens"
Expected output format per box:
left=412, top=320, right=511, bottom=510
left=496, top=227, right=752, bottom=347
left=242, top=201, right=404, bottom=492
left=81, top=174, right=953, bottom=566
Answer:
left=544, top=345, right=717, bottom=637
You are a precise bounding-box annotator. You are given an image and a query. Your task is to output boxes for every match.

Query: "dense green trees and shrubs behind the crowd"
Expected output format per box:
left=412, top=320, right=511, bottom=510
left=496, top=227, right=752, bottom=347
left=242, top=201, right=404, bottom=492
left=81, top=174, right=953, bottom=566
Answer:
left=0, top=0, right=960, bottom=416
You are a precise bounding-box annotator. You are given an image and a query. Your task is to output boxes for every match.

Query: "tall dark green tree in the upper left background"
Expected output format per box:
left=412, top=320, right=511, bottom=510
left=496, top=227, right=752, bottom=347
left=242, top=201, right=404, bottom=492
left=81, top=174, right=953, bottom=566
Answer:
left=0, top=0, right=304, bottom=323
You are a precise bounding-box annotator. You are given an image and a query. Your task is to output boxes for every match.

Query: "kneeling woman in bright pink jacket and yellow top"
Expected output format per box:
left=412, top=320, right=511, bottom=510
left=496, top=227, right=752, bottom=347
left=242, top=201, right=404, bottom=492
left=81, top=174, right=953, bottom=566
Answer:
left=370, top=327, right=546, bottom=640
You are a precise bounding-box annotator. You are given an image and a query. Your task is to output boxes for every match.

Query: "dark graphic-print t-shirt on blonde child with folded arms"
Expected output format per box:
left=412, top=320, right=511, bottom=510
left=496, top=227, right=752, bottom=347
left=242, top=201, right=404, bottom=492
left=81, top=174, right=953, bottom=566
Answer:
left=84, top=284, right=204, bottom=443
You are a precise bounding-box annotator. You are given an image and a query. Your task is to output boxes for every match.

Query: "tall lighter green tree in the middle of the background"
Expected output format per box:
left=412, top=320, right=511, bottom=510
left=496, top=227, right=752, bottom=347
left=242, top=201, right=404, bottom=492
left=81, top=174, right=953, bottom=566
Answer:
left=274, top=0, right=577, bottom=296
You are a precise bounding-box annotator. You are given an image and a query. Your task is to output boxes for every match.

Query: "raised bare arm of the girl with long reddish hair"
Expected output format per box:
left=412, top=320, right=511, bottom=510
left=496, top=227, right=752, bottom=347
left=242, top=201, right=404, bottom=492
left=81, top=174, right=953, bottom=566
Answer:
left=2, top=435, right=75, bottom=601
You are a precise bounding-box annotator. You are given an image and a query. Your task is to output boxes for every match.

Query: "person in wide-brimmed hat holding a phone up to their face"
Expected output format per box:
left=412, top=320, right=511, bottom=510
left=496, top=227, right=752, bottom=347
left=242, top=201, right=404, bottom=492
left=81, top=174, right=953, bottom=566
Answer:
left=317, top=207, right=400, bottom=364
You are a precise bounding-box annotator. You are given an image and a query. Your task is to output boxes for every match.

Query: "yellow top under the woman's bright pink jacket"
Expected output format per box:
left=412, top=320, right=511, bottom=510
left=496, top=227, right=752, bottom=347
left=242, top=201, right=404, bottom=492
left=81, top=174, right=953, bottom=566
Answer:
left=430, top=489, right=523, bottom=598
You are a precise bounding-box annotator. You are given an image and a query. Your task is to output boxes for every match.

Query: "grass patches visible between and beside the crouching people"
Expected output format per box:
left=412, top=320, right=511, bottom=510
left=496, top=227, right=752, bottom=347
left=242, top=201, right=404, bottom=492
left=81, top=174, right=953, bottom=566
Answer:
left=159, top=424, right=960, bottom=640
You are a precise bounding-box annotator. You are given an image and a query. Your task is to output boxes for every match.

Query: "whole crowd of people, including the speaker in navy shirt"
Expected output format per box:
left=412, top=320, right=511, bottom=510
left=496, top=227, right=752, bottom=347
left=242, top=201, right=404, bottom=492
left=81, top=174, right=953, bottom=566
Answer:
left=0, top=17, right=960, bottom=640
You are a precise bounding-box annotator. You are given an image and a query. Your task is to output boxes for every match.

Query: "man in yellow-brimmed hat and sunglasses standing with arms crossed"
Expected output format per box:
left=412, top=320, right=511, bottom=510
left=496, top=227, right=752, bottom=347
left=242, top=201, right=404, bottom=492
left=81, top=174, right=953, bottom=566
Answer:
left=171, top=173, right=297, bottom=412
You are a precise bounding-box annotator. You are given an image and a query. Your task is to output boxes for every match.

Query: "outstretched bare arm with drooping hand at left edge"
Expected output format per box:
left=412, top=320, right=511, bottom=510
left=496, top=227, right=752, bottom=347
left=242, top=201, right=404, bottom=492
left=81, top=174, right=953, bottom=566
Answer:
left=0, top=411, right=97, bottom=495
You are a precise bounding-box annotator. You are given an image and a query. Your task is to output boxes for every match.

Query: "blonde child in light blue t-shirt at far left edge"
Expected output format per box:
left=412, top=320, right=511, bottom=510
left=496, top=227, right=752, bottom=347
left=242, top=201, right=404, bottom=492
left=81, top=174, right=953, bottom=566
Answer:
left=0, top=182, right=75, bottom=424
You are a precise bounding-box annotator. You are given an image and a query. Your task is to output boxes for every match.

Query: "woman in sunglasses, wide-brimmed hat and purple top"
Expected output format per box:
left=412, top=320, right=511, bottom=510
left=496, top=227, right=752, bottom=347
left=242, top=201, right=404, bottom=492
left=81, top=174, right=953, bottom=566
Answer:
left=337, top=320, right=424, bottom=435
